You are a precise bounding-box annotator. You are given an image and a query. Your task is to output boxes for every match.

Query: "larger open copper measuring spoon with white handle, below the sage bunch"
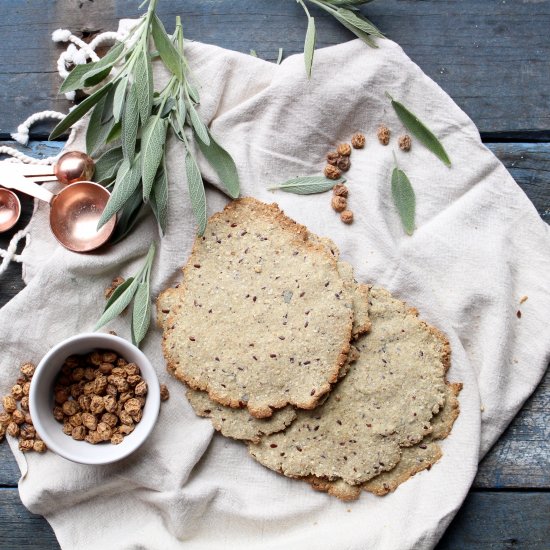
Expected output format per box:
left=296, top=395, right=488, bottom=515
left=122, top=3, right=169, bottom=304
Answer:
left=2, top=175, right=116, bottom=252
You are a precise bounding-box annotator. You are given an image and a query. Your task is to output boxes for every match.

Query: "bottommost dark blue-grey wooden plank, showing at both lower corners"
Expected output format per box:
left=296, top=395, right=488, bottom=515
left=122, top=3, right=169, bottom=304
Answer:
left=0, top=489, right=550, bottom=550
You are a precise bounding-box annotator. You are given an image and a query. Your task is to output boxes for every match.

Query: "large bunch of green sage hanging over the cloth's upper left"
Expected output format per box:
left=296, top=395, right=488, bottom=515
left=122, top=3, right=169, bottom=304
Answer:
left=50, top=0, right=240, bottom=242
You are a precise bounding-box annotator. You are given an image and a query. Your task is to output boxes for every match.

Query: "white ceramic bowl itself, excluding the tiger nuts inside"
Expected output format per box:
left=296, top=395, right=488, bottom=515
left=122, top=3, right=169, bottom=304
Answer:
left=29, top=333, right=160, bottom=464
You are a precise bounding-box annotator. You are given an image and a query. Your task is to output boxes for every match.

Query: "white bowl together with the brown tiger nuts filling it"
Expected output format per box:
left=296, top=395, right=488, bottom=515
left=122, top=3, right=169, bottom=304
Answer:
left=29, top=333, right=160, bottom=464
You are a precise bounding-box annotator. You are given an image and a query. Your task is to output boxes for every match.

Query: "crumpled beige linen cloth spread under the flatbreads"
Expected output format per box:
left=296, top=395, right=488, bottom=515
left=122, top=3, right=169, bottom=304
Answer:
left=0, top=22, right=550, bottom=550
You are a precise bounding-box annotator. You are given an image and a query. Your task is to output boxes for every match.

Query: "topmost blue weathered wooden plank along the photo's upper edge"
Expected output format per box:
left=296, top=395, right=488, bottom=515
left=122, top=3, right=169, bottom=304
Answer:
left=0, top=0, right=550, bottom=139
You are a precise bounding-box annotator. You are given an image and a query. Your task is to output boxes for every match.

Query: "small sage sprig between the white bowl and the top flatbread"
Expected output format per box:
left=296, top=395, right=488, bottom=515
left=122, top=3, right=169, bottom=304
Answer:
left=94, top=243, right=155, bottom=346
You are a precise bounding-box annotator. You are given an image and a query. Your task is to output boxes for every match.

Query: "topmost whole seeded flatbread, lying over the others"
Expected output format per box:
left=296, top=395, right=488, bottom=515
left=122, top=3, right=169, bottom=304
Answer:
left=163, top=198, right=353, bottom=418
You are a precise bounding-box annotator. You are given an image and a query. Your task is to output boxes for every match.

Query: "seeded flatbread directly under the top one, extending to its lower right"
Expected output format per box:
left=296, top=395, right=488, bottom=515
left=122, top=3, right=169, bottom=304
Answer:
left=249, top=287, right=450, bottom=485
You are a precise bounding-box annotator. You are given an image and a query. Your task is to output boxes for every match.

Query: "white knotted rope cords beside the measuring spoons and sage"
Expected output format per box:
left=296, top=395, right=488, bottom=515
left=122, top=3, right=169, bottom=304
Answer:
left=0, top=29, right=124, bottom=276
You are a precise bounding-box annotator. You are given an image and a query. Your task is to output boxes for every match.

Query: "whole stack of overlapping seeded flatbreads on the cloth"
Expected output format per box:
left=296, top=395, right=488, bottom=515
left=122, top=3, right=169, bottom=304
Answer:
left=157, top=198, right=461, bottom=500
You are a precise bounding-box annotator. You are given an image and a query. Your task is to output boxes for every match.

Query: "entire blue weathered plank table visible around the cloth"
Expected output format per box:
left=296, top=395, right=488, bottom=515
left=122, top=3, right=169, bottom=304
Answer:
left=0, top=0, right=550, bottom=550
